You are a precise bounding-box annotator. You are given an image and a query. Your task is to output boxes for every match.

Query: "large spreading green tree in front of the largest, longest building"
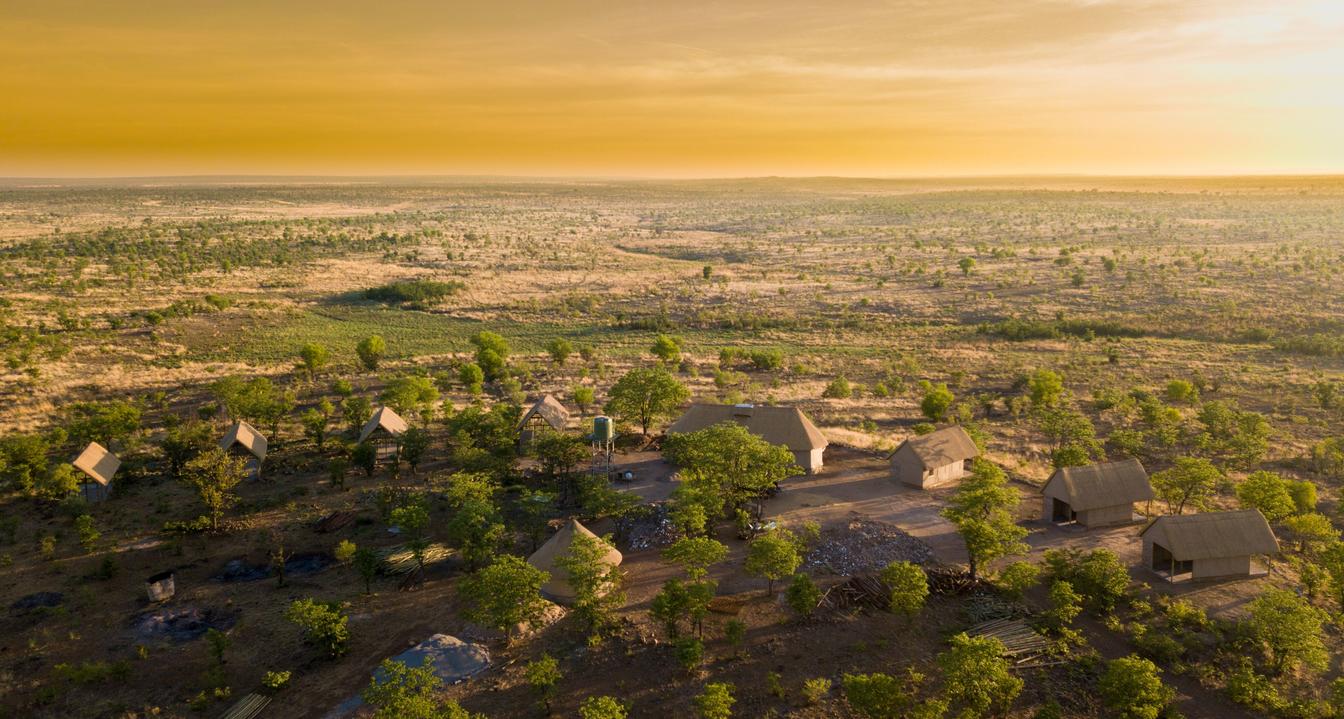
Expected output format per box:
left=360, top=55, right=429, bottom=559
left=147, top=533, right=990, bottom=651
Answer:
left=663, top=422, right=802, bottom=524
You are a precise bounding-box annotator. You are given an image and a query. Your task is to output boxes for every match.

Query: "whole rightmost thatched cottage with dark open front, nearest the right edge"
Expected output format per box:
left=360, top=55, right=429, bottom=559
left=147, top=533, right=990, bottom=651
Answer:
left=1140, top=509, right=1278, bottom=582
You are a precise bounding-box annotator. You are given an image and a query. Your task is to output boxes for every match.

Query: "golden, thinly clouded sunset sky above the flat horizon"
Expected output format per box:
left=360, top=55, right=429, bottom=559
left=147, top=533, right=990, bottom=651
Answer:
left=0, top=0, right=1344, bottom=176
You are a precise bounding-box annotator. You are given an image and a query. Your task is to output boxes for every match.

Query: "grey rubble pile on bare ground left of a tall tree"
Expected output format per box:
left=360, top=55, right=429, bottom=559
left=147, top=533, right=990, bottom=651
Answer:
left=804, top=519, right=933, bottom=577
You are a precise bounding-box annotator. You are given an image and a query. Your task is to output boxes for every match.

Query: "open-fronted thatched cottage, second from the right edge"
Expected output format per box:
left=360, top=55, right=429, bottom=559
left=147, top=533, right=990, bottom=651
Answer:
left=1040, top=460, right=1153, bottom=527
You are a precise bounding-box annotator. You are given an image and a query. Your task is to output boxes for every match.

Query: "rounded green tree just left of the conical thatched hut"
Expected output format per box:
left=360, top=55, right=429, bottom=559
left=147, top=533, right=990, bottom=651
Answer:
left=461, top=554, right=551, bottom=638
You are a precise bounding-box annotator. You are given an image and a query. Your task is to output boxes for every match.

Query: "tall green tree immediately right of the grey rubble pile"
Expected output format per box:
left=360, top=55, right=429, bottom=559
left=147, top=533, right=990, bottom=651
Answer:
left=942, top=458, right=1027, bottom=578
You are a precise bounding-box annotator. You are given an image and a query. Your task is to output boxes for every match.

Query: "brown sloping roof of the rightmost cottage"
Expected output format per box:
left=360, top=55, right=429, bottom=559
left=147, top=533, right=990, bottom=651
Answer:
left=1140, top=509, right=1278, bottom=562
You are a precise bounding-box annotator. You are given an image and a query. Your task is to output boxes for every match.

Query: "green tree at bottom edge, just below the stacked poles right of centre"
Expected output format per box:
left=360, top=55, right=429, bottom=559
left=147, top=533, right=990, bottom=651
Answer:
left=937, top=633, right=1023, bottom=716
